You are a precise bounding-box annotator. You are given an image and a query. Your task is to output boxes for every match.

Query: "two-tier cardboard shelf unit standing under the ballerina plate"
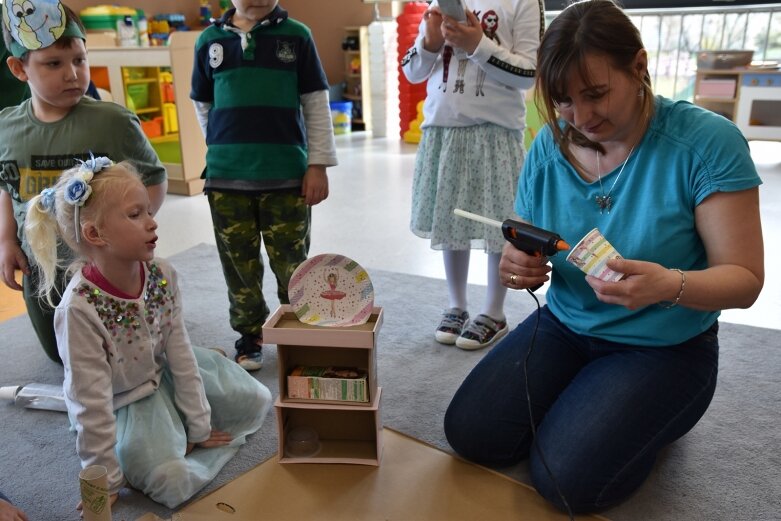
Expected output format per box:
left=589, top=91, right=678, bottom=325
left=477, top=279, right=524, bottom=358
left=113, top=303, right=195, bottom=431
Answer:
left=263, top=305, right=383, bottom=466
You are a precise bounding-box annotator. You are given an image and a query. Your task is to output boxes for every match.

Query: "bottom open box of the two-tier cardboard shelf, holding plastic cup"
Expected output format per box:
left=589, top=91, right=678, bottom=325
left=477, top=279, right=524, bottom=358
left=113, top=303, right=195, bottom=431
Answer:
left=274, top=388, right=382, bottom=466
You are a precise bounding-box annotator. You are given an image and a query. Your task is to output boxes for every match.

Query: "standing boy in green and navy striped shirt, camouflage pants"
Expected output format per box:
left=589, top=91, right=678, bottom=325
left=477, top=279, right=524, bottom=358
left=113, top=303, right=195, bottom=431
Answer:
left=190, top=0, right=337, bottom=371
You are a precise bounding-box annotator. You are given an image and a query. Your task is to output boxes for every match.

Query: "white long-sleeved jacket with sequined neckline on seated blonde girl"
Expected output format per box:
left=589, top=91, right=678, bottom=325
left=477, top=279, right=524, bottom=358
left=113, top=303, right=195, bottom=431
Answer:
left=54, top=259, right=211, bottom=494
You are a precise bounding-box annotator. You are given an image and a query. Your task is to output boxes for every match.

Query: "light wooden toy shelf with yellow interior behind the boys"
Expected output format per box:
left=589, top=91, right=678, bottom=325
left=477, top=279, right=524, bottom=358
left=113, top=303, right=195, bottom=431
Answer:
left=87, top=31, right=206, bottom=195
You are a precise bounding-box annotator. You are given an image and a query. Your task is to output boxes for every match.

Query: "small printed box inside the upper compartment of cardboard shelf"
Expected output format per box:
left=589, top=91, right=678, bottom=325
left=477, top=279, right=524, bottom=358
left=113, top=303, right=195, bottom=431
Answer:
left=287, top=365, right=369, bottom=402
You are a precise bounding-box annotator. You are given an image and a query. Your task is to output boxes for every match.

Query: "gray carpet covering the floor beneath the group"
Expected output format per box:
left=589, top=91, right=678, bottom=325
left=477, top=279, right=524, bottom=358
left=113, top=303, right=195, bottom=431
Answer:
left=0, top=245, right=781, bottom=521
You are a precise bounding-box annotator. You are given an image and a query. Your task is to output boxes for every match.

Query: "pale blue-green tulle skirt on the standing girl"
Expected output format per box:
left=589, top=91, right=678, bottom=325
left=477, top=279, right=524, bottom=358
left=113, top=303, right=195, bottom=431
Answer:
left=410, top=124, right=525, bottom=253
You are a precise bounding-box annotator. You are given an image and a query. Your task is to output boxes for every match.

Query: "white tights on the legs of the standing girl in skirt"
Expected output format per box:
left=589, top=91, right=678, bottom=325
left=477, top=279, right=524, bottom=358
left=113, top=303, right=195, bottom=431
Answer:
left=442, top=250, right=507, bottom=320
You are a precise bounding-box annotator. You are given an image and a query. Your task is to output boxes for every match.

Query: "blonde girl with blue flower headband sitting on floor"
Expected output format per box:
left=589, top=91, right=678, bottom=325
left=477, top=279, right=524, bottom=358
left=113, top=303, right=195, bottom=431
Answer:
left=25, top=157, right=271, bottom=508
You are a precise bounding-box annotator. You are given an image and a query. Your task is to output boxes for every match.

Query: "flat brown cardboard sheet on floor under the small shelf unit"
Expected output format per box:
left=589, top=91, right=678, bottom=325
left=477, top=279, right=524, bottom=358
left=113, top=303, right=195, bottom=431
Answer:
left=138, top=428, right=605, bottom=521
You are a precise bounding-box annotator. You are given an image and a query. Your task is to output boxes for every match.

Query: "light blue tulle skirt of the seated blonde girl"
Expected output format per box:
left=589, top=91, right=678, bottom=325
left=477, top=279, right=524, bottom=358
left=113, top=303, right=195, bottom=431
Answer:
left=109, top=347, right=271, bottom=508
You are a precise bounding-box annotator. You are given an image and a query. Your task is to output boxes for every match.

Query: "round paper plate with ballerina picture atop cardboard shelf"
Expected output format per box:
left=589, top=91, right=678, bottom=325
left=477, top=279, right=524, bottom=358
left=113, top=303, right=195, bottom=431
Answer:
left=288, top=253, right=374, bottom=327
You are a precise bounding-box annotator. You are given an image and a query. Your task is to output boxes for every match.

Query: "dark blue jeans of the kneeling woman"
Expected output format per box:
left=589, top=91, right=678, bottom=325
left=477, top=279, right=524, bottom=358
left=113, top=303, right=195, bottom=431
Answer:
left=445, top=306, right=719, bottom=512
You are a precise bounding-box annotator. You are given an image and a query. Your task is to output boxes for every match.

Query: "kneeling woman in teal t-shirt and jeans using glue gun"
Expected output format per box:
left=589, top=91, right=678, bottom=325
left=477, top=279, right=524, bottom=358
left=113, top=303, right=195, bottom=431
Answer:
left=445, top=0, right=764, bottom=513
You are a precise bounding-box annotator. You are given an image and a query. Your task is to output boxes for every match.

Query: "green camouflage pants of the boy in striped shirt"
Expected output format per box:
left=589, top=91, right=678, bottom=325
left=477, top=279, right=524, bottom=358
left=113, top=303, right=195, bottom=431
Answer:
left=206, top=188, right=312, bottom=335
